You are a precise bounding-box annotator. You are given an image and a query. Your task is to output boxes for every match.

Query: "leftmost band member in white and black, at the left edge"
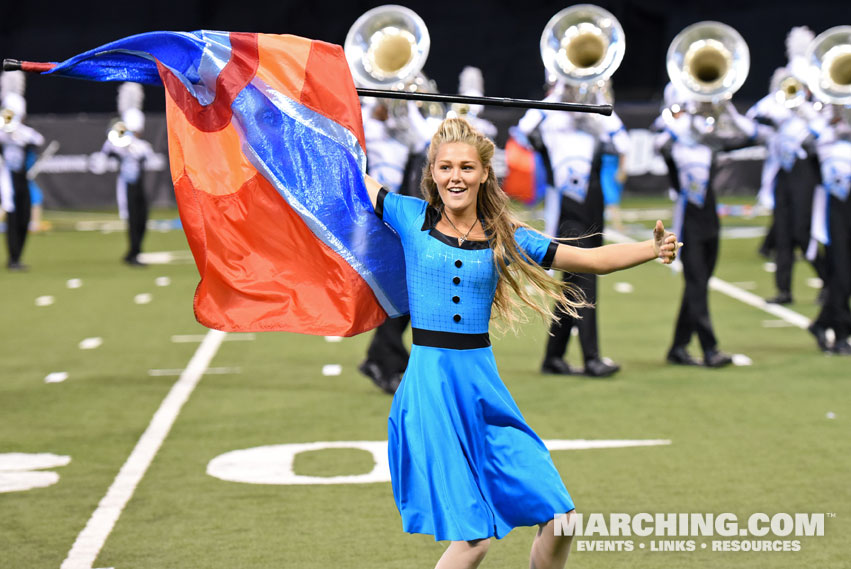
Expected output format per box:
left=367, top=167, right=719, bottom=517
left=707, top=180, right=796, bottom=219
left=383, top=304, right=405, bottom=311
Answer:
left=0, top=71, right=44, bottom=271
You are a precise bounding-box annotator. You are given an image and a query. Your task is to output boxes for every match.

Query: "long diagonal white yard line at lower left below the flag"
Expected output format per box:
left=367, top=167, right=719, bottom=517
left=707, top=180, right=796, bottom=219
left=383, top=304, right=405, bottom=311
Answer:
left=61, top=330, right=226, bottom=569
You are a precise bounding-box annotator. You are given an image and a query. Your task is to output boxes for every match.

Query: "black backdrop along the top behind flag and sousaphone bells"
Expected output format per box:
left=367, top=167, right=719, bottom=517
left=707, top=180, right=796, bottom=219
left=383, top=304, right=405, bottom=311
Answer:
left=0, top=0, right=851, bottom=114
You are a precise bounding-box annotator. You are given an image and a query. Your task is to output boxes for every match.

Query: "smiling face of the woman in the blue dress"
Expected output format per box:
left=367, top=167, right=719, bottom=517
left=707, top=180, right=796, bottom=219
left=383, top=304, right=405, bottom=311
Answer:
left=431, top=142, right=488, bottom=215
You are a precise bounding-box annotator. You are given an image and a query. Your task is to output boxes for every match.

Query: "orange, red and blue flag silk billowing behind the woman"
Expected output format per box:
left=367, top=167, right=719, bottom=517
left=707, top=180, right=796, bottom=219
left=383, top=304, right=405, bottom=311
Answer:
left=45, top=31, right=408, bottom=336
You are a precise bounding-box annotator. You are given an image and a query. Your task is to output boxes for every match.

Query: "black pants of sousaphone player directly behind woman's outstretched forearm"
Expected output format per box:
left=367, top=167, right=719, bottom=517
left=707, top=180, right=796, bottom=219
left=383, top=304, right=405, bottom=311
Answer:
left=544, top=229, right=603, bottom=362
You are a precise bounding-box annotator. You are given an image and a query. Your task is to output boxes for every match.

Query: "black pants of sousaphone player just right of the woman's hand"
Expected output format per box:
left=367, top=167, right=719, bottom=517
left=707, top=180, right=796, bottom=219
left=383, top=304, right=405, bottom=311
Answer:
left=673, top=220, right=719, bottom=353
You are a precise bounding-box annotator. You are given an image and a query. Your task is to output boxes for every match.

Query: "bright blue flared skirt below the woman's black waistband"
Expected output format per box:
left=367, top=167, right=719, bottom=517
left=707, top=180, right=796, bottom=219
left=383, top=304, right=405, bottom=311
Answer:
left=388, top=344, right=574, bottom=541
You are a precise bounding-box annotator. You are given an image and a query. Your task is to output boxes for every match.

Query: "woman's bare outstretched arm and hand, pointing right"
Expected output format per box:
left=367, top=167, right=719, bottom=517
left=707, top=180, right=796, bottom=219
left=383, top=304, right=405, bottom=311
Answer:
left=552, top=221, right=682, bottom=275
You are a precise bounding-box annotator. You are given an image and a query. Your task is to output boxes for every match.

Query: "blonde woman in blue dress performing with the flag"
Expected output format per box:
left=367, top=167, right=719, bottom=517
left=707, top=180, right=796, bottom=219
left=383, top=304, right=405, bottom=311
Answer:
left=366, top=118, right=678, bottom=569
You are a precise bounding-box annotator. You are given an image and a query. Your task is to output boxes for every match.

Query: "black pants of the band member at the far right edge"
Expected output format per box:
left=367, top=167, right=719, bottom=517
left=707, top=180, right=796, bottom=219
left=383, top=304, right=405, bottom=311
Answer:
left=816, top=196, right=851, bottom=342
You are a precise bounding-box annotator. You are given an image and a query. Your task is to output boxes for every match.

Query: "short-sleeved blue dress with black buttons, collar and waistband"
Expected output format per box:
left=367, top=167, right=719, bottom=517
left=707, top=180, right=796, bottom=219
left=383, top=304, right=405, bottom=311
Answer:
left=375, top=190, right=573, bottom=541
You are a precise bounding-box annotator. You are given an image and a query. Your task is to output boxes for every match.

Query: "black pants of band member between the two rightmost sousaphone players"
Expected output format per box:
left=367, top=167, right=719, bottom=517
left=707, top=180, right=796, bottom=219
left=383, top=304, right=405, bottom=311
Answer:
left=774, top=166, right=825, bottom=294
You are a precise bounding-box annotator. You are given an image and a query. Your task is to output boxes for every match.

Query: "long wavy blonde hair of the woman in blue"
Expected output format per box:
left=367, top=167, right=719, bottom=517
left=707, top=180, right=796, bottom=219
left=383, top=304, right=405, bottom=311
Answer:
left=421, top=118, right=589, bottom=330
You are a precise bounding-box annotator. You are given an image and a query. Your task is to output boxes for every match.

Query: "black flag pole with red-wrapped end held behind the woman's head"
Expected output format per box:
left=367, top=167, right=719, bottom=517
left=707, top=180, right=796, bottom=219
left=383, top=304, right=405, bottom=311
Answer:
left=3, top=59, right=612, bottom=115
